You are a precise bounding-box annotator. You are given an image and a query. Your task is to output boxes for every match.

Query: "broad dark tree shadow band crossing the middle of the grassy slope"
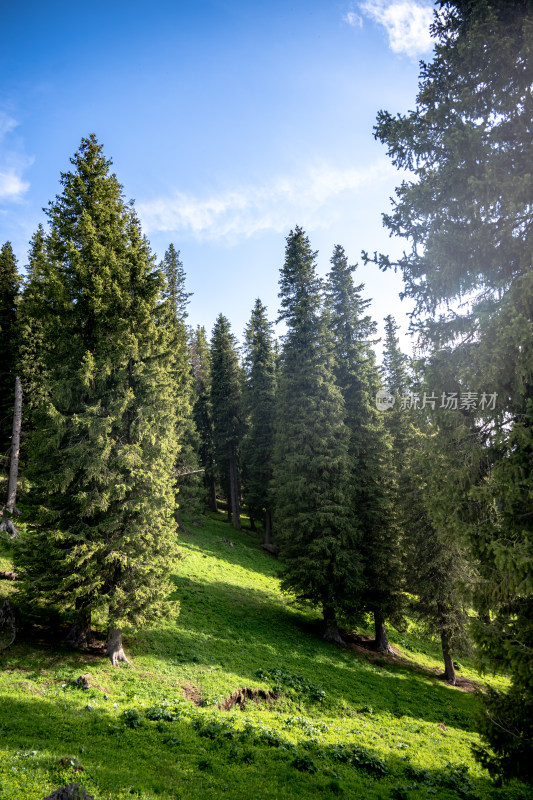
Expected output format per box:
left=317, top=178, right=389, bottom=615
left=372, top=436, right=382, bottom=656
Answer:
left=132, top=578, right=477, bottom=730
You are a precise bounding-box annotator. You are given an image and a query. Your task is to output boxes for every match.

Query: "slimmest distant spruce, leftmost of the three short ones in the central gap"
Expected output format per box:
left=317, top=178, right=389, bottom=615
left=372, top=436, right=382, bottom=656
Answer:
left=190, top=325, right=218, bottom=512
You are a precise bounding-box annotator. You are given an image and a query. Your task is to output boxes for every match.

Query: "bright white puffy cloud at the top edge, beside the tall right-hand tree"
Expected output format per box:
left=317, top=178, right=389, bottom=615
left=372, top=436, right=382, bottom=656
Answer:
left=360, top=0, right=433, bottom=58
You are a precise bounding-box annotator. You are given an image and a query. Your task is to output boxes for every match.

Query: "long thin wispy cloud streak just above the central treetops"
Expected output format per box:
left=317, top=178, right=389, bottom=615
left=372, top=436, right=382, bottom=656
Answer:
left=136, top=160, right=397, bottom=240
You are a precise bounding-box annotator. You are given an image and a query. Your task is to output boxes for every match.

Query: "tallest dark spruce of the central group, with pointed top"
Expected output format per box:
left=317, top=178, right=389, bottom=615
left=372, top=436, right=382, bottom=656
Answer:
left=273, top=227, right=362, bottom=641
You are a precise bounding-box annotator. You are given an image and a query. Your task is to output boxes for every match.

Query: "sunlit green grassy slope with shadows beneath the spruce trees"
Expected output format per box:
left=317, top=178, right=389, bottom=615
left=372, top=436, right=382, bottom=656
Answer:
left=0, top=515, right=531, bottom=800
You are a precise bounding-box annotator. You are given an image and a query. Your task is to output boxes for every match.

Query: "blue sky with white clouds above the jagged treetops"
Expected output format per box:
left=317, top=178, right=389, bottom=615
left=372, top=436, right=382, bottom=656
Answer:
left=0, top=0, right=432, bottom=354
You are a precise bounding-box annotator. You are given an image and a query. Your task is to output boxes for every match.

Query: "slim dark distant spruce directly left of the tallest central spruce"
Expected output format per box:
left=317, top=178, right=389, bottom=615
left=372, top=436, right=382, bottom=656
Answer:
left=243, top=299, right=275, bottom=547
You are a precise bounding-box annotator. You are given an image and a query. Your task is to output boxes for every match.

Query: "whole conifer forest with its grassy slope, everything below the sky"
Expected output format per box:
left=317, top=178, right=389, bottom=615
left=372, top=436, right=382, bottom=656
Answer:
left=0, top=0, right=533, bottom=800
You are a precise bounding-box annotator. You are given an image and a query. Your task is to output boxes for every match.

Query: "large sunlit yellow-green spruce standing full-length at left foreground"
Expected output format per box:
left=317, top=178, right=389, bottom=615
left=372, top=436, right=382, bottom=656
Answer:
left=16, top=135, right=176, bottom=664
